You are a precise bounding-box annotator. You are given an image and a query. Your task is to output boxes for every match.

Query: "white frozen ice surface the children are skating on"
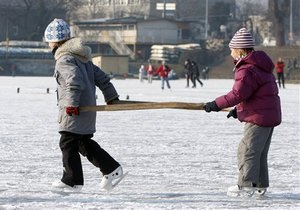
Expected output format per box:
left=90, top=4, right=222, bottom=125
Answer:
left=0, top=77, right=300, bottom=210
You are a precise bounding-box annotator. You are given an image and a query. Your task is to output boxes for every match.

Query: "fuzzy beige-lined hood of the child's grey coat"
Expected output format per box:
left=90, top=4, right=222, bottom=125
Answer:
left=54, top=38, right=92, bottom=63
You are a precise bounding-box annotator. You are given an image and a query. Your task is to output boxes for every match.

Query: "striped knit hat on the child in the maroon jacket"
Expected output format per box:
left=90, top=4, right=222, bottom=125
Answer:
left=229, top=28, right=254, bottom=49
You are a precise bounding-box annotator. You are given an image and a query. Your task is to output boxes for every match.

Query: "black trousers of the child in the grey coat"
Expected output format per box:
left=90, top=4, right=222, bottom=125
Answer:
left=59, top=132, right=120, bottom=186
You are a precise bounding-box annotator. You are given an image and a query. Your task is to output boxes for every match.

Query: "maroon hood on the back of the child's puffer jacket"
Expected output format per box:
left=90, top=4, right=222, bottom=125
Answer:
left=236, top=51, right=274, bottom=72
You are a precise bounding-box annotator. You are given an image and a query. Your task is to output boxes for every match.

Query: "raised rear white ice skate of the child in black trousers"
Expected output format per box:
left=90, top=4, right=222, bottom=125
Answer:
left=100, top=166, right=128, bottom=191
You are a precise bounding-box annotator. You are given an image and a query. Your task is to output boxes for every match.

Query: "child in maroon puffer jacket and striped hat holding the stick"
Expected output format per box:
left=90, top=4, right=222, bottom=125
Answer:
left=203, top=28, right=281, bottom=196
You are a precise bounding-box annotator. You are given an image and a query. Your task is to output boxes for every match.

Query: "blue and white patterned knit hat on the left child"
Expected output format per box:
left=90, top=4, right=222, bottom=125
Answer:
left=44, top=18, right=71, bottom=42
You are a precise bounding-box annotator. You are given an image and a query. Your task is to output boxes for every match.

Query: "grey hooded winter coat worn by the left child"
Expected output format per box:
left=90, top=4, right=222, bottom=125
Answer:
left=54, top=38, right=119, bottom=134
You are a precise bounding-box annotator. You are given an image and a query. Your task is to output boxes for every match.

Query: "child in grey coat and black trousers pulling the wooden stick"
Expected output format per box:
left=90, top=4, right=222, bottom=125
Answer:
left=45, top=19, right=123, bottom=191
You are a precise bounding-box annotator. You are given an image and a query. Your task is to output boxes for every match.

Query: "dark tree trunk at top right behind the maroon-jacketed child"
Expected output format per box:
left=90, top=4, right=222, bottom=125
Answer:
left=269, top=0, right=290, bottom=46
